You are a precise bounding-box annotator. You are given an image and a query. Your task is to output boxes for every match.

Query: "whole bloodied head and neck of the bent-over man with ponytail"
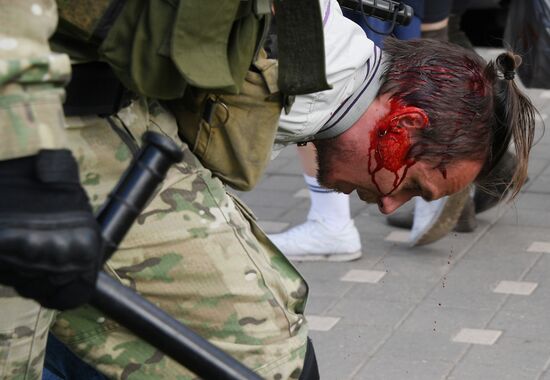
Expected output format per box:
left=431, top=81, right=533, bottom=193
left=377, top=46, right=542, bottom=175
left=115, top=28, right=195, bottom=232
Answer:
left=283, top=39, right=535, bottom=229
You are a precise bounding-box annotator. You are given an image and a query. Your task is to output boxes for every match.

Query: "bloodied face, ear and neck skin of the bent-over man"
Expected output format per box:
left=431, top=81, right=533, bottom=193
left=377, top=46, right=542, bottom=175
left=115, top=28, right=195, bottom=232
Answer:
left=315, top=94, right=482, bottom=214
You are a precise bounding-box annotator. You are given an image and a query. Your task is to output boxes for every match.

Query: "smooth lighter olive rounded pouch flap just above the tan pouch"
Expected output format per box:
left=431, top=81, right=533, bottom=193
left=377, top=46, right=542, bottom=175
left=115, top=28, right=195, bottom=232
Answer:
left=172, top=0, right=259, bottom=93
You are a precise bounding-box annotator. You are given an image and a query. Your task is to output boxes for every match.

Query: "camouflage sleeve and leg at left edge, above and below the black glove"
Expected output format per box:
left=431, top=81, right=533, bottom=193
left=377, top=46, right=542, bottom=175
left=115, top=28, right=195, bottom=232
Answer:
left=0, top=0, right=70, bottom=379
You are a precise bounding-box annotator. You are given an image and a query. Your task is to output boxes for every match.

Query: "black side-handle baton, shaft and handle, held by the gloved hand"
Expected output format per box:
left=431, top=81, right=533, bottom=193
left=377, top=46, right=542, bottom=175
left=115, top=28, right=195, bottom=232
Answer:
left=90, top=132, right=261, bottom=380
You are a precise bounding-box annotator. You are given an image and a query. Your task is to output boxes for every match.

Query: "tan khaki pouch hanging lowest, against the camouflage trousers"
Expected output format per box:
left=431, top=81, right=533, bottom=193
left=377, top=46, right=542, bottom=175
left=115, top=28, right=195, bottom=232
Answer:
left=168, top=51, right=282, bottom=191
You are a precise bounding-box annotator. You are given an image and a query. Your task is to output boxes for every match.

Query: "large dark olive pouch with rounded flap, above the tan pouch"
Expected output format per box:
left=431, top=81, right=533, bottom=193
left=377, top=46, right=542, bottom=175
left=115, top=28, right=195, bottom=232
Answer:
left=99, top=0, right=268, bottom=99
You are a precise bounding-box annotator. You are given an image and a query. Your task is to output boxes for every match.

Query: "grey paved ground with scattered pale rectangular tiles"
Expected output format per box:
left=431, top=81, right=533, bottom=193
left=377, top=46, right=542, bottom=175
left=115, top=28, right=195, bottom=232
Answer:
left=232, top=49, right=550, bottom=380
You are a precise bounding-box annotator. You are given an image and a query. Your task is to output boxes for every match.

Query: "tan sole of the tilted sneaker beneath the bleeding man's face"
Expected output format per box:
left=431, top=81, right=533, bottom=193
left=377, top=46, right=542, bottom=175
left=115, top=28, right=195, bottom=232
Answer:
left=410, top=187, right=470, bottom=247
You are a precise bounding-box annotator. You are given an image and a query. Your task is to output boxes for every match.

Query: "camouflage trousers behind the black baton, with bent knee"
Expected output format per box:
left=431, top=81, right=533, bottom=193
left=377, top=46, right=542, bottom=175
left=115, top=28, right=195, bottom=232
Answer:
left=0, top=99, right=307, bottom=379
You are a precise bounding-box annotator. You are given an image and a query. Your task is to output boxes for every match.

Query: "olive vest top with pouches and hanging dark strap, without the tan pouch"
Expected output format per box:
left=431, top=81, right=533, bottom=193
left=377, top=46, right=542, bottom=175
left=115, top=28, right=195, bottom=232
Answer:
left=52, top=0, right=329, bottom=99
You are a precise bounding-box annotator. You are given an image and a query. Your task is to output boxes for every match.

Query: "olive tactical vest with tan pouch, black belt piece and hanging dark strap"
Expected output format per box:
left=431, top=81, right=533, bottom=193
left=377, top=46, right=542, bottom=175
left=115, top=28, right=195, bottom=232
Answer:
left=55, top=0, right=329, bottom=190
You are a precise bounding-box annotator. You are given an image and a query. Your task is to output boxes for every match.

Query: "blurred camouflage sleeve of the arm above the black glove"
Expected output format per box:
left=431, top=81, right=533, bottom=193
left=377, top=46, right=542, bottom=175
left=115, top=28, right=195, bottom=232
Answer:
left=0, top=0, right=71, bottom=160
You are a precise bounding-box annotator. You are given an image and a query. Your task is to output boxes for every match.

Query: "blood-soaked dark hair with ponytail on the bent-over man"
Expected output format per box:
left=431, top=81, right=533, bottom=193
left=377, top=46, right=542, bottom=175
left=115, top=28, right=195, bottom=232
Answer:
left=379, top=38, right=536, bottom=196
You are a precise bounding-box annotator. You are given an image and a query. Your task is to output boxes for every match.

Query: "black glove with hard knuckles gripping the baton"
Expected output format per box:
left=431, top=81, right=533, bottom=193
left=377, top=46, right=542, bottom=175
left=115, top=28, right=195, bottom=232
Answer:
left=0, top=150, right=101, bottom=310
